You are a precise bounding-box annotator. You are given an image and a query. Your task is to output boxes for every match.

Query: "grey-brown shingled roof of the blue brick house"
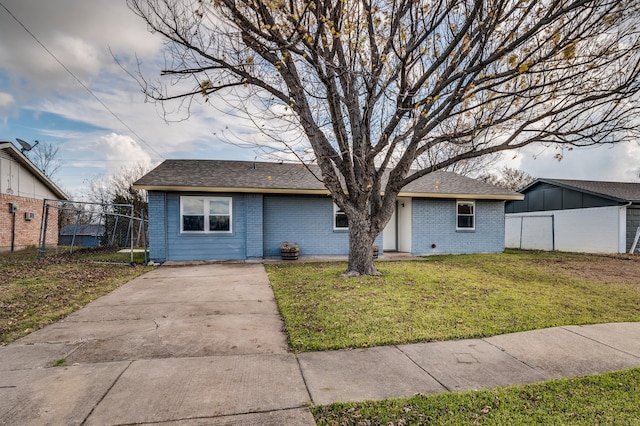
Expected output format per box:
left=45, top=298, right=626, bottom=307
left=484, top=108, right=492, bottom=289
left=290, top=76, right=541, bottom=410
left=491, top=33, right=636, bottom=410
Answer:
left=134, top=160, right=522, bottom=200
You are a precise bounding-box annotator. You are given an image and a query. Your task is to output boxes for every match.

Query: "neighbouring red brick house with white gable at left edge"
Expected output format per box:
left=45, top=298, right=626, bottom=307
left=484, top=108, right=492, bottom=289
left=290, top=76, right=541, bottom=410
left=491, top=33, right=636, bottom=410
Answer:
left=0, top=142, right=67, bottom=251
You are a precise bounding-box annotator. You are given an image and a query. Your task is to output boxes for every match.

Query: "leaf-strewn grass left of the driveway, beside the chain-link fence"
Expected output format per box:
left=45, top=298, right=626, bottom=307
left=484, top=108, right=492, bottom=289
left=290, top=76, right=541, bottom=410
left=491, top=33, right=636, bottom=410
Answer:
left=0, top=249, right=151, bottom=345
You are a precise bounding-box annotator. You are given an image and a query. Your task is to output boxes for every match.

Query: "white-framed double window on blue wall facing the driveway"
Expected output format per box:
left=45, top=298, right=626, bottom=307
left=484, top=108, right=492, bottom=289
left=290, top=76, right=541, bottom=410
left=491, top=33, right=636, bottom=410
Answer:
left=180, top=197, right=231, bottom=233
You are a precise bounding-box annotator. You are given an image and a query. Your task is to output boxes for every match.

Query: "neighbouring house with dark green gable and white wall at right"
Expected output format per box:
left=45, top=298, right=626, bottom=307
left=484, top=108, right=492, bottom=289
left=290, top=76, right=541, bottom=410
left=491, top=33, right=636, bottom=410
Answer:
left=505, top=179, right=640, bottom=253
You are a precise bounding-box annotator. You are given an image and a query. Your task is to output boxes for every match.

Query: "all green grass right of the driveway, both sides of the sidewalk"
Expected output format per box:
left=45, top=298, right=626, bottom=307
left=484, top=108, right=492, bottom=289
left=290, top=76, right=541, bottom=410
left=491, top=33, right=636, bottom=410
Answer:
left=267, top=251, right=640, bottom=425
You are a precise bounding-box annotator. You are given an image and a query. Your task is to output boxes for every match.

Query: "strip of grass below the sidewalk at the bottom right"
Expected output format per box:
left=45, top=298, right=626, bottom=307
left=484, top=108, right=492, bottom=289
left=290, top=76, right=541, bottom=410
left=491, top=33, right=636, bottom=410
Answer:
left=312, top=368, right=640, bottom=426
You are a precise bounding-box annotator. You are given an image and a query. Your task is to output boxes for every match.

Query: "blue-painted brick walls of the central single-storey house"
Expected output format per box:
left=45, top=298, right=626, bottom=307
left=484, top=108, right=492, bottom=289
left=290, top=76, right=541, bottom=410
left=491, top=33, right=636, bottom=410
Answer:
left=149, top=191, right=504, bottom=262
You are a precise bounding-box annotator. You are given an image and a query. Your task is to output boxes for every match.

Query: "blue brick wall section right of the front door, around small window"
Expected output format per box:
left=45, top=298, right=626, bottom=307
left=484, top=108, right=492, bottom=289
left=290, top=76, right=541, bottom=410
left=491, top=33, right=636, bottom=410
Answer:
left=411, top=198, right=504, bottom=255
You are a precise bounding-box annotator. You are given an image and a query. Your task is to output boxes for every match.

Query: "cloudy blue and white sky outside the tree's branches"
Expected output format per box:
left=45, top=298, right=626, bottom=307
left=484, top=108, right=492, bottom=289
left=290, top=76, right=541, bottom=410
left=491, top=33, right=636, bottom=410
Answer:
left=0, top=0, right=640, bottom=197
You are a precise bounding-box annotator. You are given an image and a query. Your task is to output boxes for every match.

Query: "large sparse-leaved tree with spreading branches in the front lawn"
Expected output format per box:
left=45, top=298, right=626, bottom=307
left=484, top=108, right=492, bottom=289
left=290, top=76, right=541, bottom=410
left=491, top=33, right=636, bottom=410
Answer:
left=128, top=0, right=640, bottom=275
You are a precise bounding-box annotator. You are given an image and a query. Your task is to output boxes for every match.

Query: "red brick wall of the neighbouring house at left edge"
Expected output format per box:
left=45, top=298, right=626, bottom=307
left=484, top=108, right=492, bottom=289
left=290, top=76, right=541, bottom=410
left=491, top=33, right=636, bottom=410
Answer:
left=0, top=194, right=58, bottom=251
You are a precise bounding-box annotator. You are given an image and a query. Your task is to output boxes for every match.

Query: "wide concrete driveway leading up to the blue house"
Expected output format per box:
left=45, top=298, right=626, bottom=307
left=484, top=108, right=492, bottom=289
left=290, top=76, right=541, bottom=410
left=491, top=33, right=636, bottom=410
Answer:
left=0, top=264, right=315, bottom=425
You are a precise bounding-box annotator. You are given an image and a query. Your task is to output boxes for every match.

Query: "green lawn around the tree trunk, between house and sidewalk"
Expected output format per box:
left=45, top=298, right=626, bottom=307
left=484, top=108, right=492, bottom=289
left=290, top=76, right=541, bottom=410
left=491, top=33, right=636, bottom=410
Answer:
left=267, top=251, right=640, bottom=351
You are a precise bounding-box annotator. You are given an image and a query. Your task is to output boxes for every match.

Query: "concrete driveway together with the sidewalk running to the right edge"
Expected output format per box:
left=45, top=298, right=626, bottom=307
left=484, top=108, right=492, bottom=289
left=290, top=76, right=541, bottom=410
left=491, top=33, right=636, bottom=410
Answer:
left=0, top=264, right=640, bottom=425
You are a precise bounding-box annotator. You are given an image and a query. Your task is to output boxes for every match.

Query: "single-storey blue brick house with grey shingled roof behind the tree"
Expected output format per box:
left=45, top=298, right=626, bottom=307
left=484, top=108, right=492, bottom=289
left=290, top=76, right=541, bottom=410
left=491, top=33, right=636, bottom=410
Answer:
left=133, top=160, right=522, bottom=262
